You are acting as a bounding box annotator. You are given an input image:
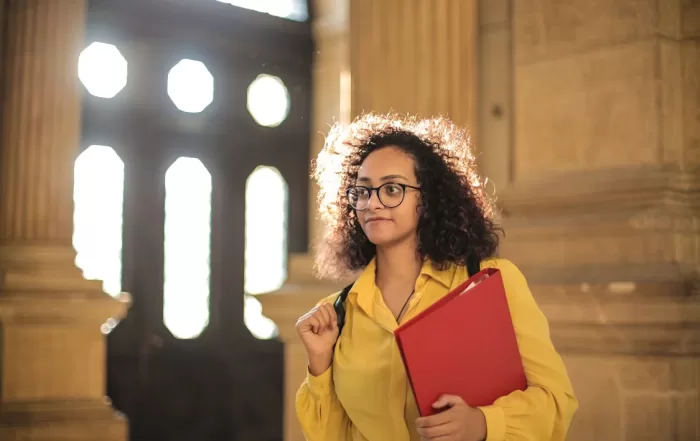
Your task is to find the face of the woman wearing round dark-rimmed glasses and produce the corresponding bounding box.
[355,146,420,247]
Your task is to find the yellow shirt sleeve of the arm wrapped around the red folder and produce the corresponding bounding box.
[480,259,578,441]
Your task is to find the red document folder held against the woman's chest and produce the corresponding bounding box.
[394,268,527,415]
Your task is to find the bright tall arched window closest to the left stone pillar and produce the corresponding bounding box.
[73,145,124,296]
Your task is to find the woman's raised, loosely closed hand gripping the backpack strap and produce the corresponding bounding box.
[296,303,339,376]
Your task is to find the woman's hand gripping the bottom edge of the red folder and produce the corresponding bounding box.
[416,395,486,441]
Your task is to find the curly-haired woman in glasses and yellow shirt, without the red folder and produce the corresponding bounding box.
[296,114,578,441]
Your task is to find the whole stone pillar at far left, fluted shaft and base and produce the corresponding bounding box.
[0,0,127,441]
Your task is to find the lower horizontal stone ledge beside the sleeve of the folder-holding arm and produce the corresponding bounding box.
[532,281,700,356]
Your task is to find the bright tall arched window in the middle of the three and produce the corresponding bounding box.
[163,157,212,339]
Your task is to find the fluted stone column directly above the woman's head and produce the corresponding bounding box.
[350,0,478,130]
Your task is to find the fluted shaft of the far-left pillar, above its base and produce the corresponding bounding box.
[0,0,80,245]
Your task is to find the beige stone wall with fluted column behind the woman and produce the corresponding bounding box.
[263,0,700,441]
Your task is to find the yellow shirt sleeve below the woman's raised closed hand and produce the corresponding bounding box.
[295,294,352,441]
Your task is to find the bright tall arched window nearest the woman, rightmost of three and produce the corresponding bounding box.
[244,166,288,338]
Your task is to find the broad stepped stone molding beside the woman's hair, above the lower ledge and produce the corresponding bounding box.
[499,167,700,289]
